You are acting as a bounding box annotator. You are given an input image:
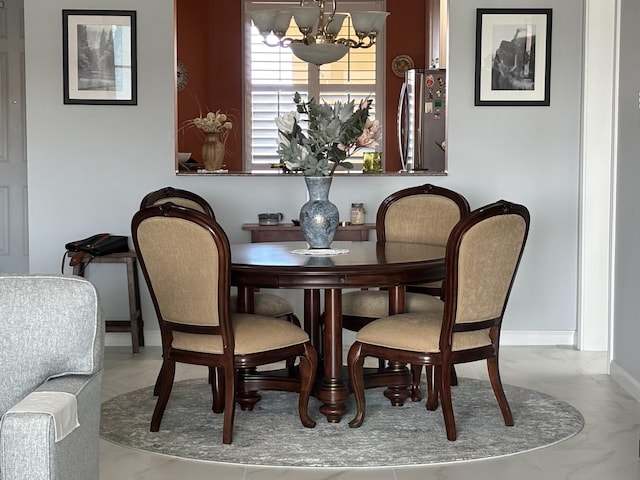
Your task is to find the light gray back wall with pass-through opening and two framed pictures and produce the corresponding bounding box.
[25,0,584,343]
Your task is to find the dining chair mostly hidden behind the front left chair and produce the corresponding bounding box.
[140,187,301,326]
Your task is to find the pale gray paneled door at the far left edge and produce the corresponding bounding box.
[0,0,29,273]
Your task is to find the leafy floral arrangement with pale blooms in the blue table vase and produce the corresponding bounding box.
[276,92,382,176]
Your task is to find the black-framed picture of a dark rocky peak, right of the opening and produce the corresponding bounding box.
[475,8,552,106]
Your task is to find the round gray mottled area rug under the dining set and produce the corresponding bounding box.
[101,378,584,468]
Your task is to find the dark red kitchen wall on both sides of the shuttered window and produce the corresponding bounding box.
[176,0,427,172]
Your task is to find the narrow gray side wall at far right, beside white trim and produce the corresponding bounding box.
[613,0,640,382]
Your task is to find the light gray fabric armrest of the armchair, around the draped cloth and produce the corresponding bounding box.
[0,370,102,480]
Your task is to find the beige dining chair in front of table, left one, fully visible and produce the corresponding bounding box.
[131,202,317,444]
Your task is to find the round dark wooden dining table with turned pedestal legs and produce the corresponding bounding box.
[231,242,445,422]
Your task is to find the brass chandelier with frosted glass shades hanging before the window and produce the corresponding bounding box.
[249,0,389,67]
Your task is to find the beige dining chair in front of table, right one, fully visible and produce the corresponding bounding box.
[347,200,529,440]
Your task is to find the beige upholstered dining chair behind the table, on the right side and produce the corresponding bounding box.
[342,184,470,394]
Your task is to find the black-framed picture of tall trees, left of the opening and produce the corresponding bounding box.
[62,10,138,105]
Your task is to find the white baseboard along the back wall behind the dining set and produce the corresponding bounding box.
[105,330,576,347]
